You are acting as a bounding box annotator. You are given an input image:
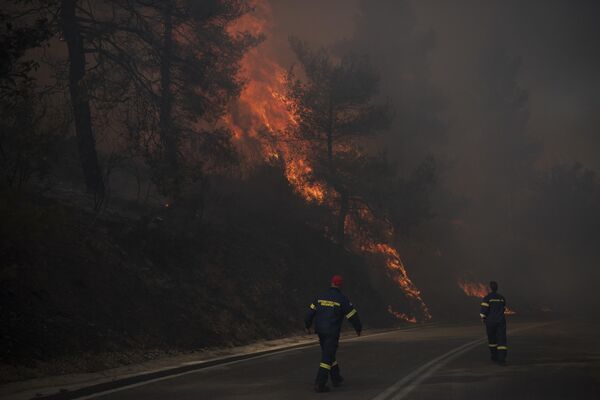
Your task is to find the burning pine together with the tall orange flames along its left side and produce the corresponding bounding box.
[220,1,431,322]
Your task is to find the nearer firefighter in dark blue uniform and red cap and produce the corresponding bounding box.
[304,275,362,393]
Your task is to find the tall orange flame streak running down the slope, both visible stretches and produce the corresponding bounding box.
[225,0,431,322]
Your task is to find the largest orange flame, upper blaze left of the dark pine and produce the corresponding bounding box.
[225,1,326,204]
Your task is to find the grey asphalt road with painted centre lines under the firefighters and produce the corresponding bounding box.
[72,320,600,400]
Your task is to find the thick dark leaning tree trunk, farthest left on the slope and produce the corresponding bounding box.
[60,0,104,198]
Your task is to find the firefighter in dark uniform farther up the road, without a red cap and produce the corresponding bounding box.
[479,281,508,364]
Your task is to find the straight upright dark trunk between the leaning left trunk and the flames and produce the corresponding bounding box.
[159,1,178,183]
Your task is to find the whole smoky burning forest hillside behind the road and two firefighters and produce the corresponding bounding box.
[0,0,600,381]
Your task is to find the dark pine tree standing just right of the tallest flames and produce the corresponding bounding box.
[287,38,390,245]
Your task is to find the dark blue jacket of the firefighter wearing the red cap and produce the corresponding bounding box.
[304,287,362,336]
